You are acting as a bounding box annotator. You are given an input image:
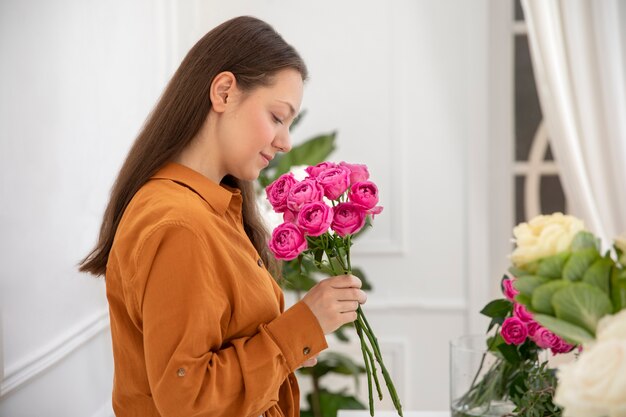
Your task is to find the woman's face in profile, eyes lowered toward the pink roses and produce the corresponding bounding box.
[217,69,303,180]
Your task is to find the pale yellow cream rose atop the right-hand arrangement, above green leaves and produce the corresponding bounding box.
[511,213,585,267]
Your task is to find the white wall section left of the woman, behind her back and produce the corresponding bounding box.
[0,0,172,417]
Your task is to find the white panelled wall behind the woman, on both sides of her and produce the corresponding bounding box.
[0,0,508,416]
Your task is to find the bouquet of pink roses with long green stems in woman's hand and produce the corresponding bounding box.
[265,162,402,416]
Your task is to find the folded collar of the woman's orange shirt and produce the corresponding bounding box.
[151,162,241,215]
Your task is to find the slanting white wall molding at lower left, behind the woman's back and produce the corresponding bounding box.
[0,309,109,399]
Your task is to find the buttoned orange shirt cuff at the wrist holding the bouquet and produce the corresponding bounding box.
[266,301,328,372]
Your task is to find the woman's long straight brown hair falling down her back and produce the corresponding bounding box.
[79,16,307,276]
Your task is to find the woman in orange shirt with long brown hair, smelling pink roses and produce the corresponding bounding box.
[80,17,366,417]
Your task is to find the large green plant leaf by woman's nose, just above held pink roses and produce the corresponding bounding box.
[274,132,337,178]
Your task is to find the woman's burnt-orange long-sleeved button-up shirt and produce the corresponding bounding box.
[106,163,327,417]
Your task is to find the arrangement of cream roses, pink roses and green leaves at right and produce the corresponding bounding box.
[460,213,626,417]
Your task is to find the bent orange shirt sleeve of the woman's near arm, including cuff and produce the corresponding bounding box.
[135,223,327,417]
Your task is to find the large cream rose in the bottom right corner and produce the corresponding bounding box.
[554,339,626,417]
